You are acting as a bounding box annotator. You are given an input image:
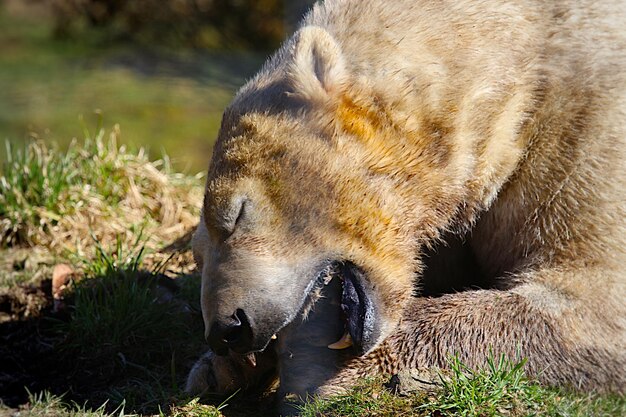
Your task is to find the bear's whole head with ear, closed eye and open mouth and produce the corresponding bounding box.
[193,27,447,355]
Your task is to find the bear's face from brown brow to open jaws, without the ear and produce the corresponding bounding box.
[193,108,413,354]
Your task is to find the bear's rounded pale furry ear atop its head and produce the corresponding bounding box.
[289,26,347,99]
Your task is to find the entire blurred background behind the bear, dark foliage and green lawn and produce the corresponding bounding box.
[0,0,313,173]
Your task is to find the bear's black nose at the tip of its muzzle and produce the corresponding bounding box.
[208,308,252,355]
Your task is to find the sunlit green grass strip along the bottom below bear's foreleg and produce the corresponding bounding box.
[301,355,626,417]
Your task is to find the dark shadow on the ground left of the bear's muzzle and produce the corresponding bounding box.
[0,271,195,412]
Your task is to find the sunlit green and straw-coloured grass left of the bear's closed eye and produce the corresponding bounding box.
[0,126,202,252]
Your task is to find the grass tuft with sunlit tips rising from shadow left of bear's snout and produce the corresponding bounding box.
[60,234,158,354]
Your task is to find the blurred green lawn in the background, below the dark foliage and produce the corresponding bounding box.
[0,5,264,171]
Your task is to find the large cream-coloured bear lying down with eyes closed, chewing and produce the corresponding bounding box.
[187,0,626,399]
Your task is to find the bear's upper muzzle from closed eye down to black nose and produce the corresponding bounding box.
[193,179,328,353]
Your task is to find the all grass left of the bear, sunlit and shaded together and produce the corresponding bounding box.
[0,126,206,415]
